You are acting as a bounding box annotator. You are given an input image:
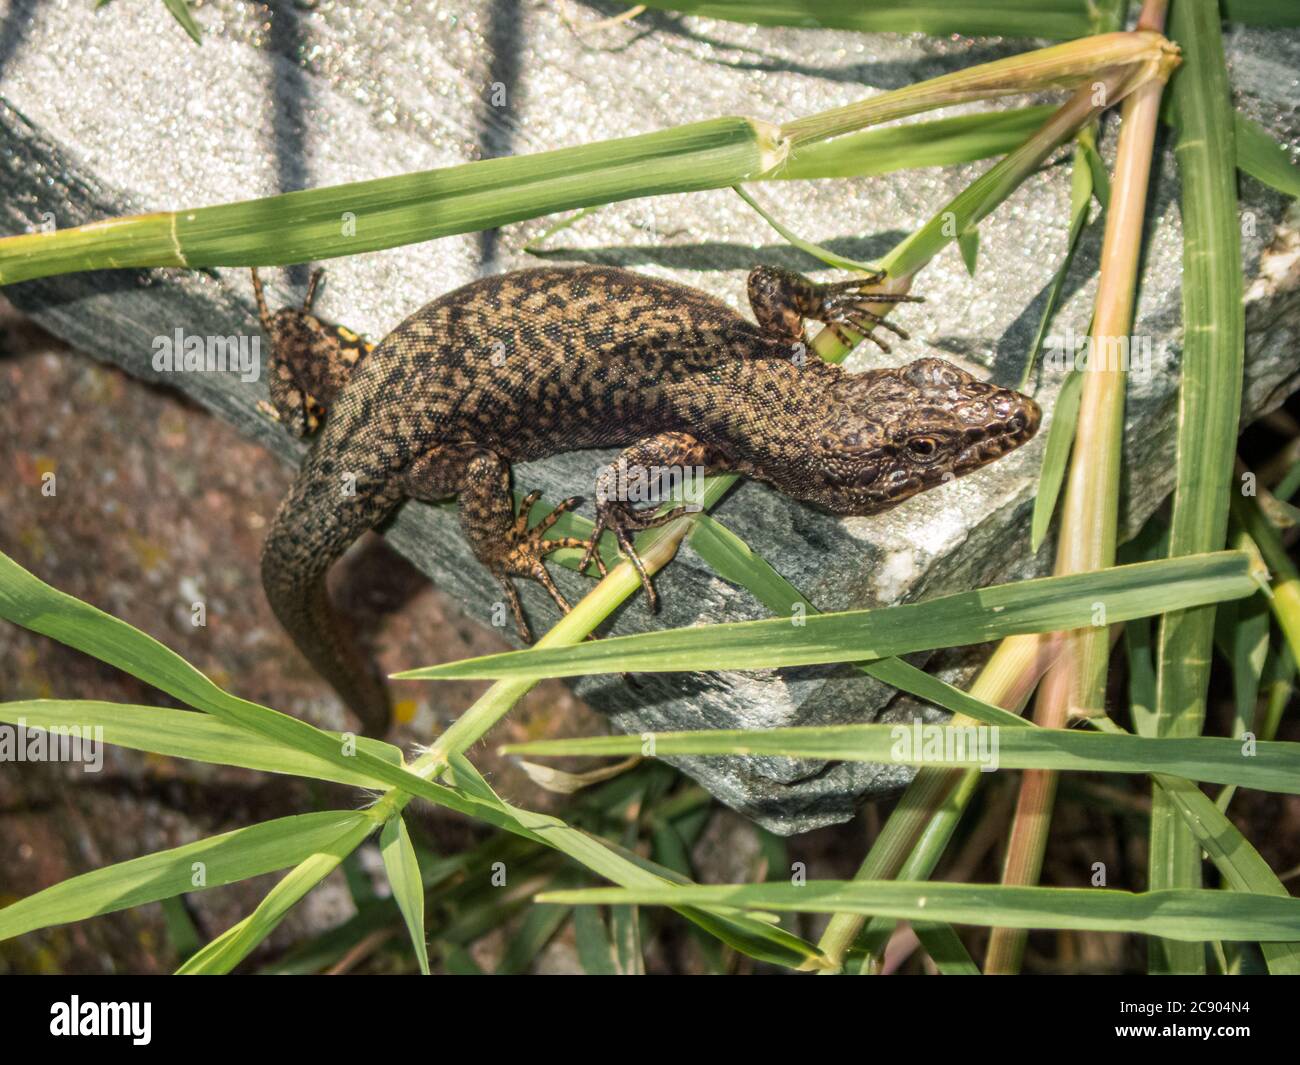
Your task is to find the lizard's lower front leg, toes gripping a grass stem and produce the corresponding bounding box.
[579,433,731,612]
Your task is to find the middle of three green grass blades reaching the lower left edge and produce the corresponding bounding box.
[0,700,402,788]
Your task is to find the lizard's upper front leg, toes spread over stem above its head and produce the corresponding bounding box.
[749,267,924,351]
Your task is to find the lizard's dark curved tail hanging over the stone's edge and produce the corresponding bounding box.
[261,460,400,736]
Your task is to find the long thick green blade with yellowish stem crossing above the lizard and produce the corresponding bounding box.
[0,33,1167,285]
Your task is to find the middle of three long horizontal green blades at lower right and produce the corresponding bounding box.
[503,722,1300,795]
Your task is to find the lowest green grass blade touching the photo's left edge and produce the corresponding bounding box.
[0,810,373,939]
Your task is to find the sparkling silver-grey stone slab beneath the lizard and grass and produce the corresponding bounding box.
[0,0,1300,832]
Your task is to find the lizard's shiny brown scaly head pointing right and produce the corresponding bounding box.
[805,359,1041,515]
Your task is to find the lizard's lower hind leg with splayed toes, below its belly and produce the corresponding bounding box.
[404,443,589,644]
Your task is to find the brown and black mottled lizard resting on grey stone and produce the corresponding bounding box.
[254,265,1040,735]
